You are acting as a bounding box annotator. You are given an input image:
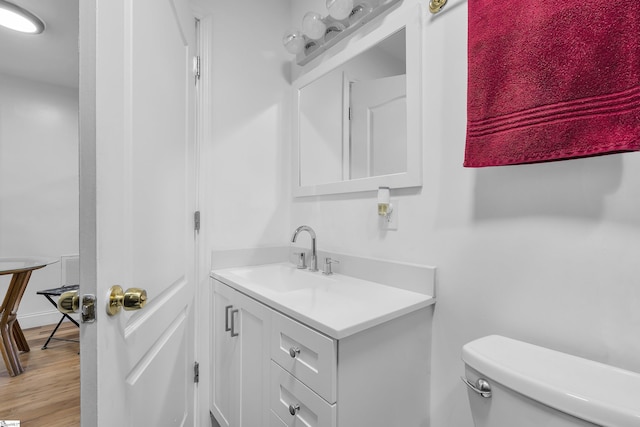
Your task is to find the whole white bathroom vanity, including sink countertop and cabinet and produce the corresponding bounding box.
[210,264,434,427]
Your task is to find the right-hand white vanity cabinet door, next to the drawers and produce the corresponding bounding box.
[234,292,271,427]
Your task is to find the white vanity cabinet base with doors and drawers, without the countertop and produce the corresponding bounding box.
[212,279,432,427]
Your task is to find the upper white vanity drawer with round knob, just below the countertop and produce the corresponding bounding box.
[271,313,337,403]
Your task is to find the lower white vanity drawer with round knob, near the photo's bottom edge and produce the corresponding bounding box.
[269,361,336,427]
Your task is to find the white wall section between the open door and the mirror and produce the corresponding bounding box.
[204,0,291,250]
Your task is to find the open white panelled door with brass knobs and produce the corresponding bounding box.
[79,0,196,427]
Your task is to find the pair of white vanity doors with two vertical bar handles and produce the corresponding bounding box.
[211,280,272,427]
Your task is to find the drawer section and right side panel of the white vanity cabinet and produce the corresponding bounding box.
[269,307,432,427]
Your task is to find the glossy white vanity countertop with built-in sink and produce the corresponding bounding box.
[211,263,435,339]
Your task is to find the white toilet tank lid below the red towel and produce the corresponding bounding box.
[462,335,640,427]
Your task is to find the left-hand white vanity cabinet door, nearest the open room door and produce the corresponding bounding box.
[211,280,240,427]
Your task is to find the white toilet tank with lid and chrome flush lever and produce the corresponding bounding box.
[462,335,640,427]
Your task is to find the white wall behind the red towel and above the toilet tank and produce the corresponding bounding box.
[289,0,640,427]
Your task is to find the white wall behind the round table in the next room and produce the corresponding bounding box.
[0,74,78,328]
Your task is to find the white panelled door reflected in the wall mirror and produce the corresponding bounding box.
[349,74,407,179]
